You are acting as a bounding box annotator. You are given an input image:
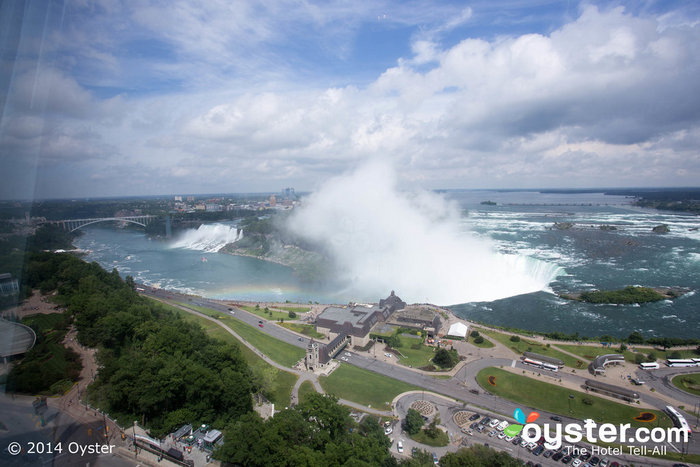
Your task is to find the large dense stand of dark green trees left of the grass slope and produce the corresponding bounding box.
[15,253,253,436]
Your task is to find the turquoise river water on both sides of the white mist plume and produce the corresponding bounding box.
[75,191,700,337]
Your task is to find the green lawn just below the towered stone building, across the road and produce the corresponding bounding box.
[319,364,421,410]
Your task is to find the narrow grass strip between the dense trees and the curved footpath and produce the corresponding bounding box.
[156,303,297,407]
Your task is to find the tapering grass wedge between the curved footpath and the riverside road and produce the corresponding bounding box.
[174,305,305,367]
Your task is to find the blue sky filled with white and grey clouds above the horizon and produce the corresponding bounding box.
[0,0,700,199]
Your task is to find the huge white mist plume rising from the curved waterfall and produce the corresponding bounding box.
[289,161,561,305]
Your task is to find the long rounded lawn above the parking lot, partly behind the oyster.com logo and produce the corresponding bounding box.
[476,368,673,428]
